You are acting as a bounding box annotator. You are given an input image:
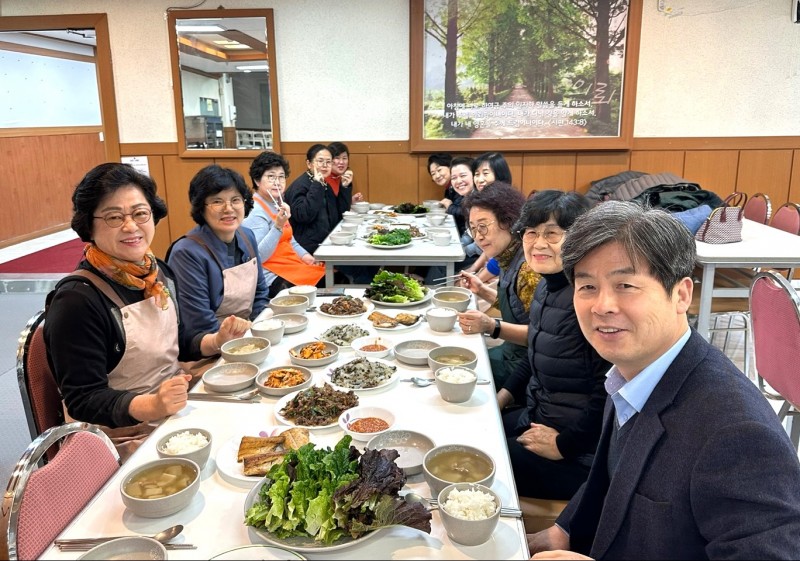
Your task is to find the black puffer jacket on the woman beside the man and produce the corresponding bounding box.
[503,273,611,459]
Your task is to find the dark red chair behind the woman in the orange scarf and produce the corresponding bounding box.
[17,310,64,458]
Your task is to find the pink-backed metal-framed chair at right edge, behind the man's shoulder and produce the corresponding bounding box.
[750,270,800,448]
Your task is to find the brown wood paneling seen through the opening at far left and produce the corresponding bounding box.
[0,127,105,247]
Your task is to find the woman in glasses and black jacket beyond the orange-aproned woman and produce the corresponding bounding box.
[286,144,340,253]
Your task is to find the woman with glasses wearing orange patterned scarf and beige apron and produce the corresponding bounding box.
[44,163,236,459]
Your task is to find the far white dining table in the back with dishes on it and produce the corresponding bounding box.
[314,210,466,287]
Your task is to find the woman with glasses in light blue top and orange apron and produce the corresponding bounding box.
[242,152,325,298]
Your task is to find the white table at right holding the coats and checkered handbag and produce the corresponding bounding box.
[695,218,800,339]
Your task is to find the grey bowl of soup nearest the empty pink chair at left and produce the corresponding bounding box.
[120,458,200,518]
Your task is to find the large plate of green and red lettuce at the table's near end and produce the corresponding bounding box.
[244,435,431,552]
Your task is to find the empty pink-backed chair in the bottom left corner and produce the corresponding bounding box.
[0,422,120,560]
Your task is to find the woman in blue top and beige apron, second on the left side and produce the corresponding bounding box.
[167,164,269,358]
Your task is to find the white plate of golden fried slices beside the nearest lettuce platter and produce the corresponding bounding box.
[216,426,311,487]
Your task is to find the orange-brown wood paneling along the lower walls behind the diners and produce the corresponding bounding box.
[7,135,788,257]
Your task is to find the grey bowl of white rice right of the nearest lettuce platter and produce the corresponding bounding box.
[438,483,501,545]
